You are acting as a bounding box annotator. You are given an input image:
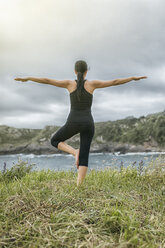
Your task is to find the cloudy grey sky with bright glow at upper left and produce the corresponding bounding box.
[0,0,165,129]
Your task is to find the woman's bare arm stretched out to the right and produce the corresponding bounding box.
[91,76,147,89]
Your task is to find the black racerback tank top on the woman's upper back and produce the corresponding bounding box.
[70,79,93,111]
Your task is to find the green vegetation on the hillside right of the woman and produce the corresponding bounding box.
[95,111,165,147]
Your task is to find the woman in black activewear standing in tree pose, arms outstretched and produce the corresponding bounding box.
[15,60,147,186]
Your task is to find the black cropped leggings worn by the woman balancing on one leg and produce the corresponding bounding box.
[51,116,95,167]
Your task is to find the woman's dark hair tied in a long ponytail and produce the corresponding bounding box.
[75,60,88,101]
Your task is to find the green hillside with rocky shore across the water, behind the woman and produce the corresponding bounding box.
[0,111,165,154]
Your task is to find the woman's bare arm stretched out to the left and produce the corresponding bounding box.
[15,77,70,88]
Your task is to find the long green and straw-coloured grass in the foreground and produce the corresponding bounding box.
[0,160,165,248]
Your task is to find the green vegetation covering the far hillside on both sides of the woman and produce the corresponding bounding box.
[0,111,165,154]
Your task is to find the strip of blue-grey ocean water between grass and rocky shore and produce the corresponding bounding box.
[0,152,165,171]
